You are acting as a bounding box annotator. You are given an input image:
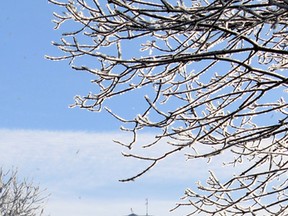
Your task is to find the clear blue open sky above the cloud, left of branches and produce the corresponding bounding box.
[0,0,119,131]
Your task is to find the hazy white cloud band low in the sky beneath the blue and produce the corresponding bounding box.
[0,129,243,216]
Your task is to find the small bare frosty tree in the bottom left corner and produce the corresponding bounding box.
[0,169,47,216]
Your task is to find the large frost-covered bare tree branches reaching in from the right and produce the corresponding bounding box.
[47,0,288,215]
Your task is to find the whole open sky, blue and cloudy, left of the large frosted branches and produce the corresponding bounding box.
[0,0,210,216]
